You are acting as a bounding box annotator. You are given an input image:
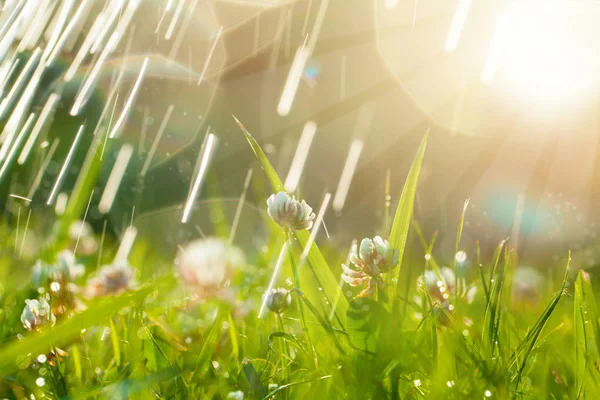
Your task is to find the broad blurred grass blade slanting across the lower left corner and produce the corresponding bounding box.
[0,286,156,376]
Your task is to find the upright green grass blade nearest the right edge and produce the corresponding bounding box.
[573,273,588,399]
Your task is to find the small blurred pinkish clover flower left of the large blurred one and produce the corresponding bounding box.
[86,261,135,297]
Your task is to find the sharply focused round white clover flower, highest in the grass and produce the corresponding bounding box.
[267,192,315,231]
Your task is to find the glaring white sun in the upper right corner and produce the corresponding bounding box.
[482,0,600,102]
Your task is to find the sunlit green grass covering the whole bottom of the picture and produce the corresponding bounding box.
[0,124,600,399]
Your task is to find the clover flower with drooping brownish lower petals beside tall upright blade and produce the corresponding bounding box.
[342,236,398,297]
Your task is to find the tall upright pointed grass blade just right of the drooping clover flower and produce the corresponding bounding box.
[389,130,429,301]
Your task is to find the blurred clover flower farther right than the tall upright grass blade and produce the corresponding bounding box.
[417,267,477,312]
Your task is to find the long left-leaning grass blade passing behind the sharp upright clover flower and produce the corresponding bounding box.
[234,117,348,323]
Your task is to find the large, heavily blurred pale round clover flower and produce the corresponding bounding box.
[176,238,245,296]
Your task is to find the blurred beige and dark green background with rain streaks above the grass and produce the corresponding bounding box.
[0,0,600,267]
